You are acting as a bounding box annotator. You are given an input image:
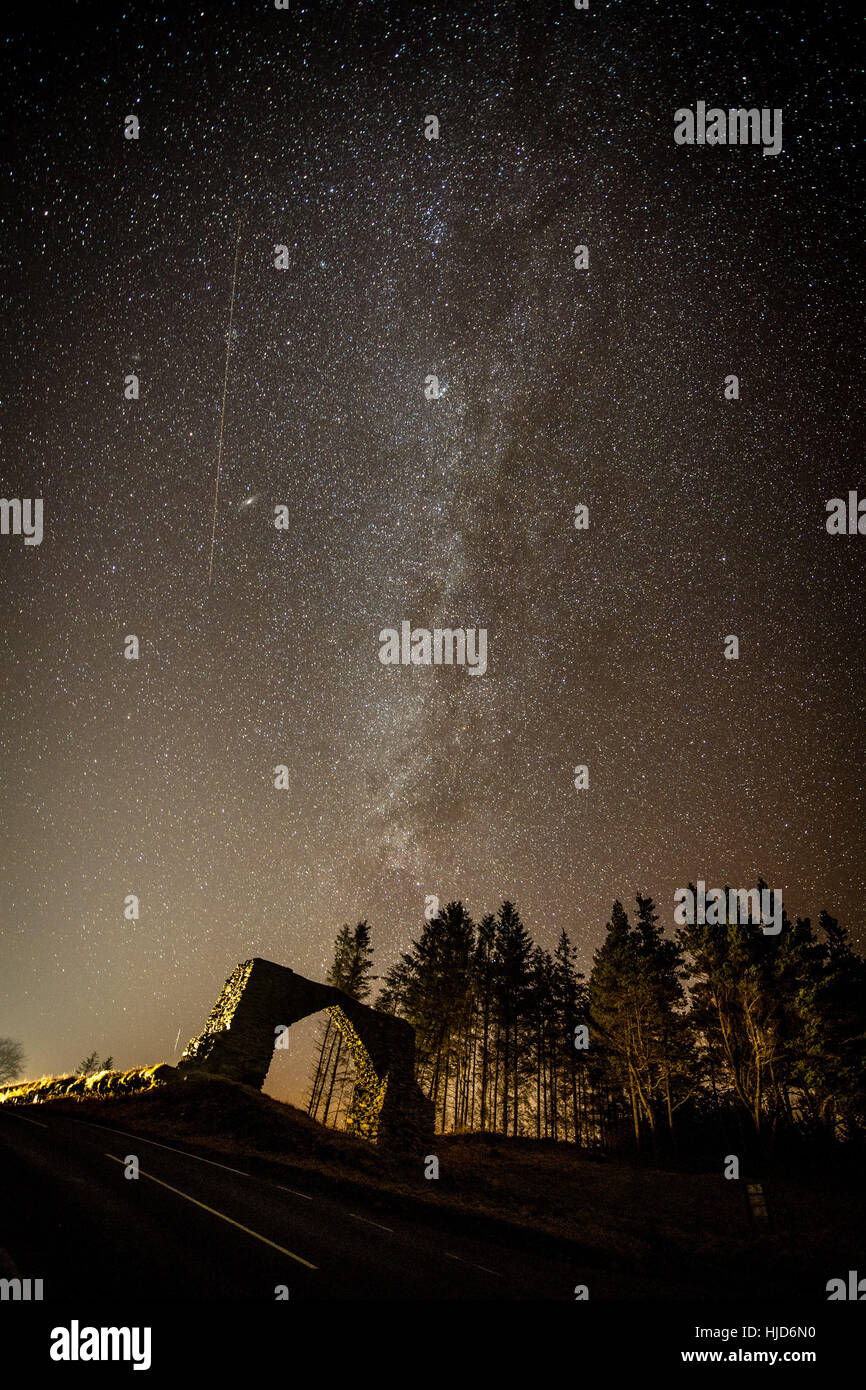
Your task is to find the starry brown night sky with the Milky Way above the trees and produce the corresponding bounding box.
[0,0,866,1097]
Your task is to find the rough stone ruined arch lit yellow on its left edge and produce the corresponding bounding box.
[178,958,434,1148]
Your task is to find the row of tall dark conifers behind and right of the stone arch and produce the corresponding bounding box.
[310,884,866,1154]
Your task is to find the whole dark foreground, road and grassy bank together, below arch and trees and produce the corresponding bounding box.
[0,1081,866,1301]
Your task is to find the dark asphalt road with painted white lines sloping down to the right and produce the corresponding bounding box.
[0,1106,633,1301]
